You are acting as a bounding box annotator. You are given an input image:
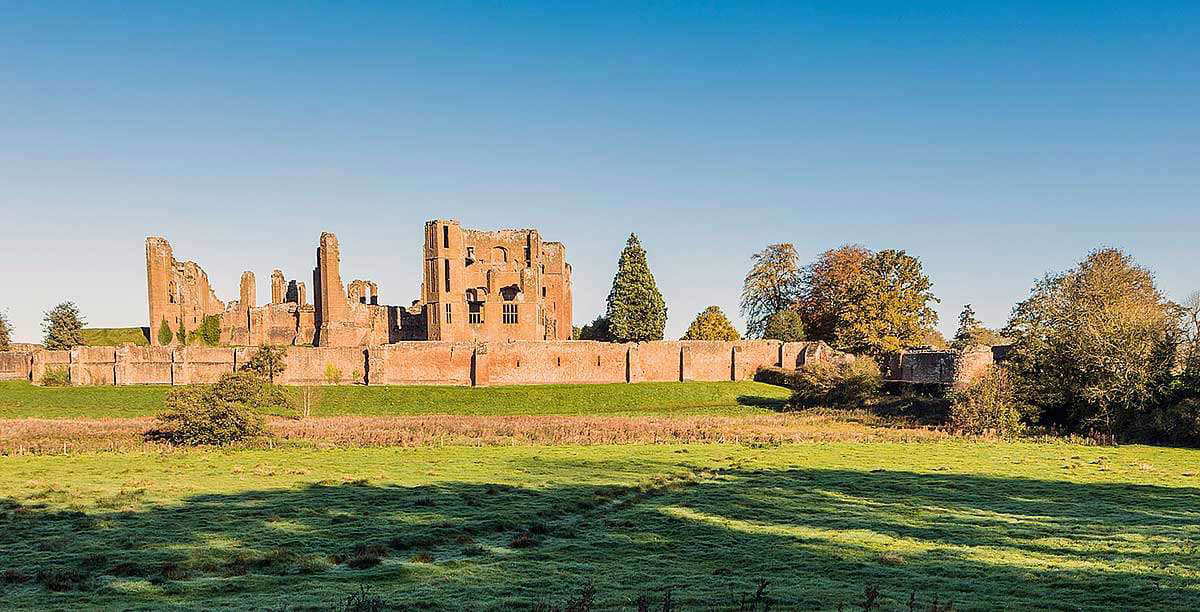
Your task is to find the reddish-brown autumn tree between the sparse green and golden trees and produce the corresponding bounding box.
[797,245,871,344]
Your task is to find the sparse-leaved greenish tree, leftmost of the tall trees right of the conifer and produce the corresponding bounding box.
[742,242,802,338]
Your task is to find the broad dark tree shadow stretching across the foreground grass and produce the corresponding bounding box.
[0,460,1200,610]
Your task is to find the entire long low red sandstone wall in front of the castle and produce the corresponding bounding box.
[23,341,823,385]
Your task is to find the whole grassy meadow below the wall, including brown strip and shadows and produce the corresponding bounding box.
[0,383,1200,610]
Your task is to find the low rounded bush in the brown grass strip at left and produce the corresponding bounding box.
[151,374,266,446]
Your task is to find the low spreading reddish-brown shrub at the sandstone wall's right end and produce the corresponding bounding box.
[791,356,883,408]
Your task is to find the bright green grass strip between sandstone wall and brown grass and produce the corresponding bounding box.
[0,380,787,419]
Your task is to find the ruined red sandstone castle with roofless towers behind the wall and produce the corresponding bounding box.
[145,220,571,347]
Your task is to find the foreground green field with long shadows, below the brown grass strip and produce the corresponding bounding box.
[0,442,1200,610]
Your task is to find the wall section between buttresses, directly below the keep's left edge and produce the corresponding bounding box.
[367,342,474,386]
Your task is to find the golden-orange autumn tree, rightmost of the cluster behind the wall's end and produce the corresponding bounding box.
[838,250,937,355]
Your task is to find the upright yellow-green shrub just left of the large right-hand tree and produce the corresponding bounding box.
[950,365,1025,437]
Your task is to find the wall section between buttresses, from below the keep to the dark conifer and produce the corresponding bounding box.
[487,341,629,385]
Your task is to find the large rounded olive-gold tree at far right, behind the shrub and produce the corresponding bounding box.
[1004,248,1180,436]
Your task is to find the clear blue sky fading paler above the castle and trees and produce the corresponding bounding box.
[0,0,1200,341]
